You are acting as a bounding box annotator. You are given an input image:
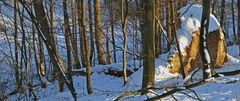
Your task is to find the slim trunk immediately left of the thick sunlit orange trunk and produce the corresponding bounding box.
[88,0,94,64]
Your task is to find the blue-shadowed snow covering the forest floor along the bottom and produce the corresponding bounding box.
[0,46,240,101]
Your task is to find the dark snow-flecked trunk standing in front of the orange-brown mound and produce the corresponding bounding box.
[200,0,213,79]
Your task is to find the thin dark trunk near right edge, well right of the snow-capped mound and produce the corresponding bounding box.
[231,0,237,44]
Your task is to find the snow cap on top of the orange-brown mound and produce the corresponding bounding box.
[177,5,220,54]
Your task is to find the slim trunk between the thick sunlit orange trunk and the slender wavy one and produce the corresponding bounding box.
[109,0,117,63]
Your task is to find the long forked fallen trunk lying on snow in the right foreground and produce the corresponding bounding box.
[114,69,240,101]
